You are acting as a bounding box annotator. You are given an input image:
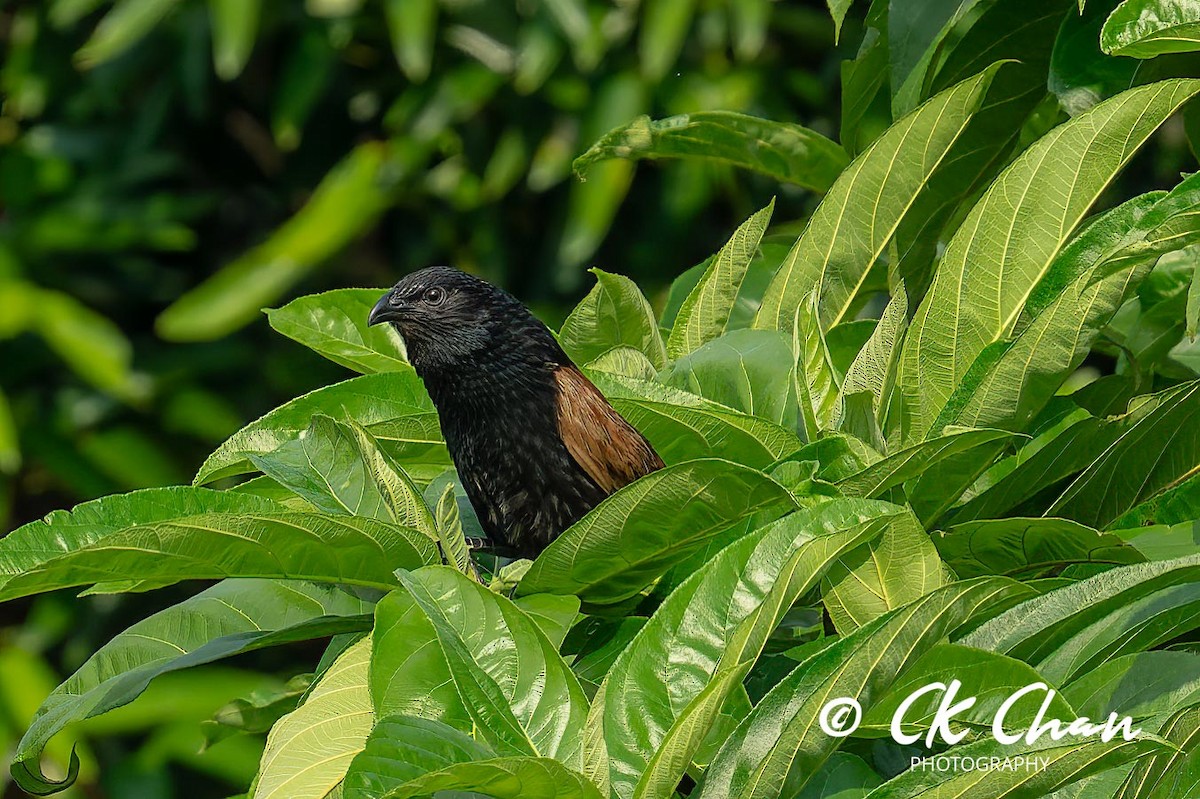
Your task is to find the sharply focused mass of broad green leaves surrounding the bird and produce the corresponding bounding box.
[7,0,1200,799]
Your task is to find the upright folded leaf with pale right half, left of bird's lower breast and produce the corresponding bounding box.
[250,414,436,539]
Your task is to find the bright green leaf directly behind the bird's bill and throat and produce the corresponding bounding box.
[266,289,408,374]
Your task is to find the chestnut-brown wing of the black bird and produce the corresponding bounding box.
[554,366,662,494]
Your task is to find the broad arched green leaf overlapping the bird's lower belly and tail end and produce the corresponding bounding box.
[517,459,796,605]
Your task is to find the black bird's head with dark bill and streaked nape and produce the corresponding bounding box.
[367,266,565,379]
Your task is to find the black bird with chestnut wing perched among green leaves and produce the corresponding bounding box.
[367,266,664,558]
